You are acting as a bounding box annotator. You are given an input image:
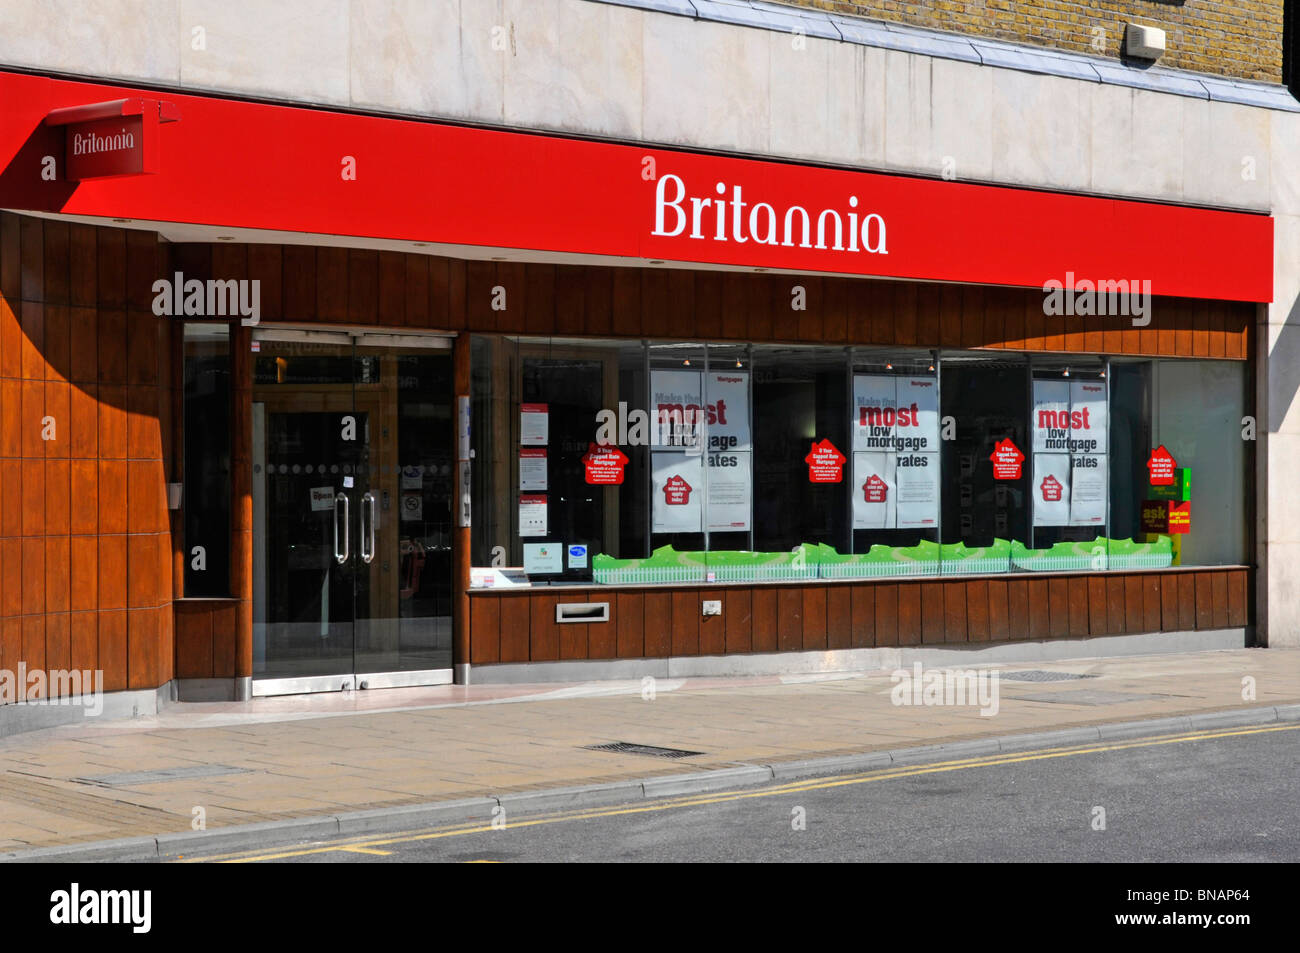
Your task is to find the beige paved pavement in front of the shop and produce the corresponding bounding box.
[0,649,1300,859]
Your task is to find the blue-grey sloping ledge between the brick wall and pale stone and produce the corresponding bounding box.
[592,0,1300,112]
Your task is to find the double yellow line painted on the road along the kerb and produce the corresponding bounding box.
[185,724,1300,863]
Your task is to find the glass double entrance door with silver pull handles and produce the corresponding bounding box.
[254,332,452,694]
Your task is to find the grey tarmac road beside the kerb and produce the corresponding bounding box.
[213,725,1300,863]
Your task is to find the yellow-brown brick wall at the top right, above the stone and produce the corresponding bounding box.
[783,0,1283,83]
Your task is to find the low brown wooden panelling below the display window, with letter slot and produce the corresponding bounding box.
[469,567,1252,664]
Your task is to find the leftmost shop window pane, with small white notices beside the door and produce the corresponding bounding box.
[471,338,649,582]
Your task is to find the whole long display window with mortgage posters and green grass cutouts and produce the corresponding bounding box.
[473,337,1248,585]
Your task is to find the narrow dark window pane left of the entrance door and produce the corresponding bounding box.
[181,324,230,598]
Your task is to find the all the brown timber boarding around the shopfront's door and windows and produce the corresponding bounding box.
[0,213,1256,690]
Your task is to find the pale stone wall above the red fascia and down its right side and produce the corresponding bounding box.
[0,0,1300,646]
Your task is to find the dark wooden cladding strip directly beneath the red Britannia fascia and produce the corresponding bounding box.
[195,243,1256,360]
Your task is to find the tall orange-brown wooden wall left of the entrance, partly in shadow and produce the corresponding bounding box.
[0,213,176,690]
